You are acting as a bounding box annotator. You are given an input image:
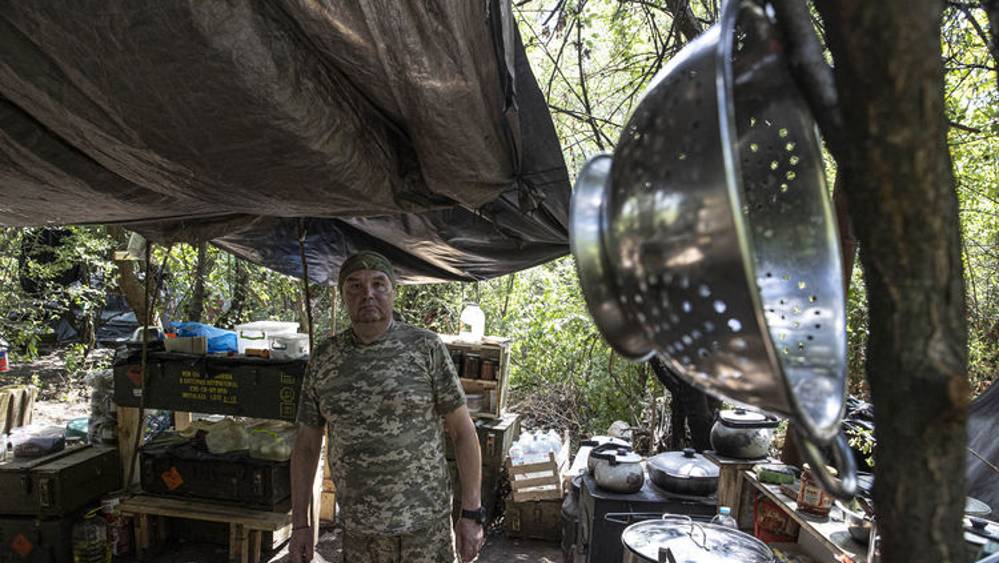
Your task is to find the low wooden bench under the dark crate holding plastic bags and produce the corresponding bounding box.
[121,495,292,563]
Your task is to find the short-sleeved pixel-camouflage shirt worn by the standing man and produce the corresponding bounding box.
[298,322,465,535]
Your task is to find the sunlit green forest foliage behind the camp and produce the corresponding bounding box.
[0,0,999,448]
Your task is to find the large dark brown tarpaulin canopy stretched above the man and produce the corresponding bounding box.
[0,0,569,282]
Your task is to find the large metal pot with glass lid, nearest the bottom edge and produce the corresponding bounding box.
[621,514,774,563]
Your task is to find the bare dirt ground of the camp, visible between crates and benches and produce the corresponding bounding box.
[7,349,562,563]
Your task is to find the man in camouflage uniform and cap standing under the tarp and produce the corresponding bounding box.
[290,252,483,563]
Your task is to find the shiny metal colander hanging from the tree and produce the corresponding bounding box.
[571,0,855,497]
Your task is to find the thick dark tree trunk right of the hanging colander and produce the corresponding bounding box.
[816,0,968,563]
